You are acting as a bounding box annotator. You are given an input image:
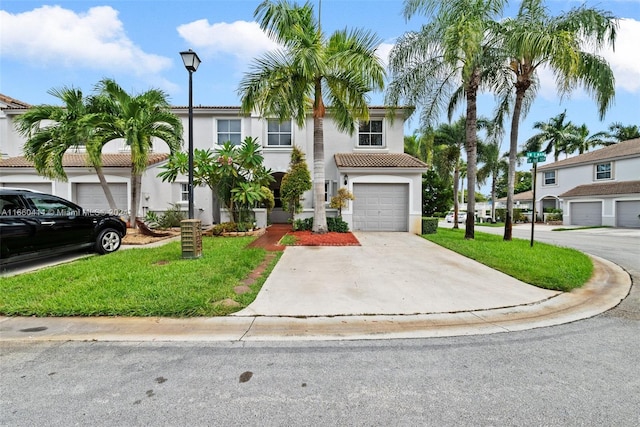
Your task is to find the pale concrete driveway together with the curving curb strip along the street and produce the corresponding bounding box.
[0,232,631,341]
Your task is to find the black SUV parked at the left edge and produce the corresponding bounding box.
[0,188,127,265]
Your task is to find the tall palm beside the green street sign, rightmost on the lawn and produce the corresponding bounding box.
[496,0,618,240]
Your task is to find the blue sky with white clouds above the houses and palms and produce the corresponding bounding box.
[0,0,640,149]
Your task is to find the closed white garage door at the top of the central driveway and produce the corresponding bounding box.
[353,184,409,231]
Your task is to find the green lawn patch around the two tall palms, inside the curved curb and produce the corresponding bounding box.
[422,228,593,291]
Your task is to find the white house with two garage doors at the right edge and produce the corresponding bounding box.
[536,138,640,228]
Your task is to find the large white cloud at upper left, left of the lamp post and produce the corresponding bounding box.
[0,6,171,75]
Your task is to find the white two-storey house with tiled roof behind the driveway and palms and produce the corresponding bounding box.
[0,97,427,233]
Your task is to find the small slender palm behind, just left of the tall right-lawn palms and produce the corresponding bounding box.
[433,117,466,228]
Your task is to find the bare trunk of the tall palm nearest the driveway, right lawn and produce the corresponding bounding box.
[464,72,480,239]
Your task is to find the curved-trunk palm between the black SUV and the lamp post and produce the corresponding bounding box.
[92,79,182,228]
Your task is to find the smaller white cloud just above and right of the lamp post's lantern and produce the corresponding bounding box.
[178,19,278,63]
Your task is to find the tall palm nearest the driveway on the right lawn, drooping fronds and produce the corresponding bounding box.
[386,0,506,239]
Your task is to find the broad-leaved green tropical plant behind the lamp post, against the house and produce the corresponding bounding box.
[158,136,273,222]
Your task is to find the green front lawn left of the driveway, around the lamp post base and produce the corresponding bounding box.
[0,237,278,317]
